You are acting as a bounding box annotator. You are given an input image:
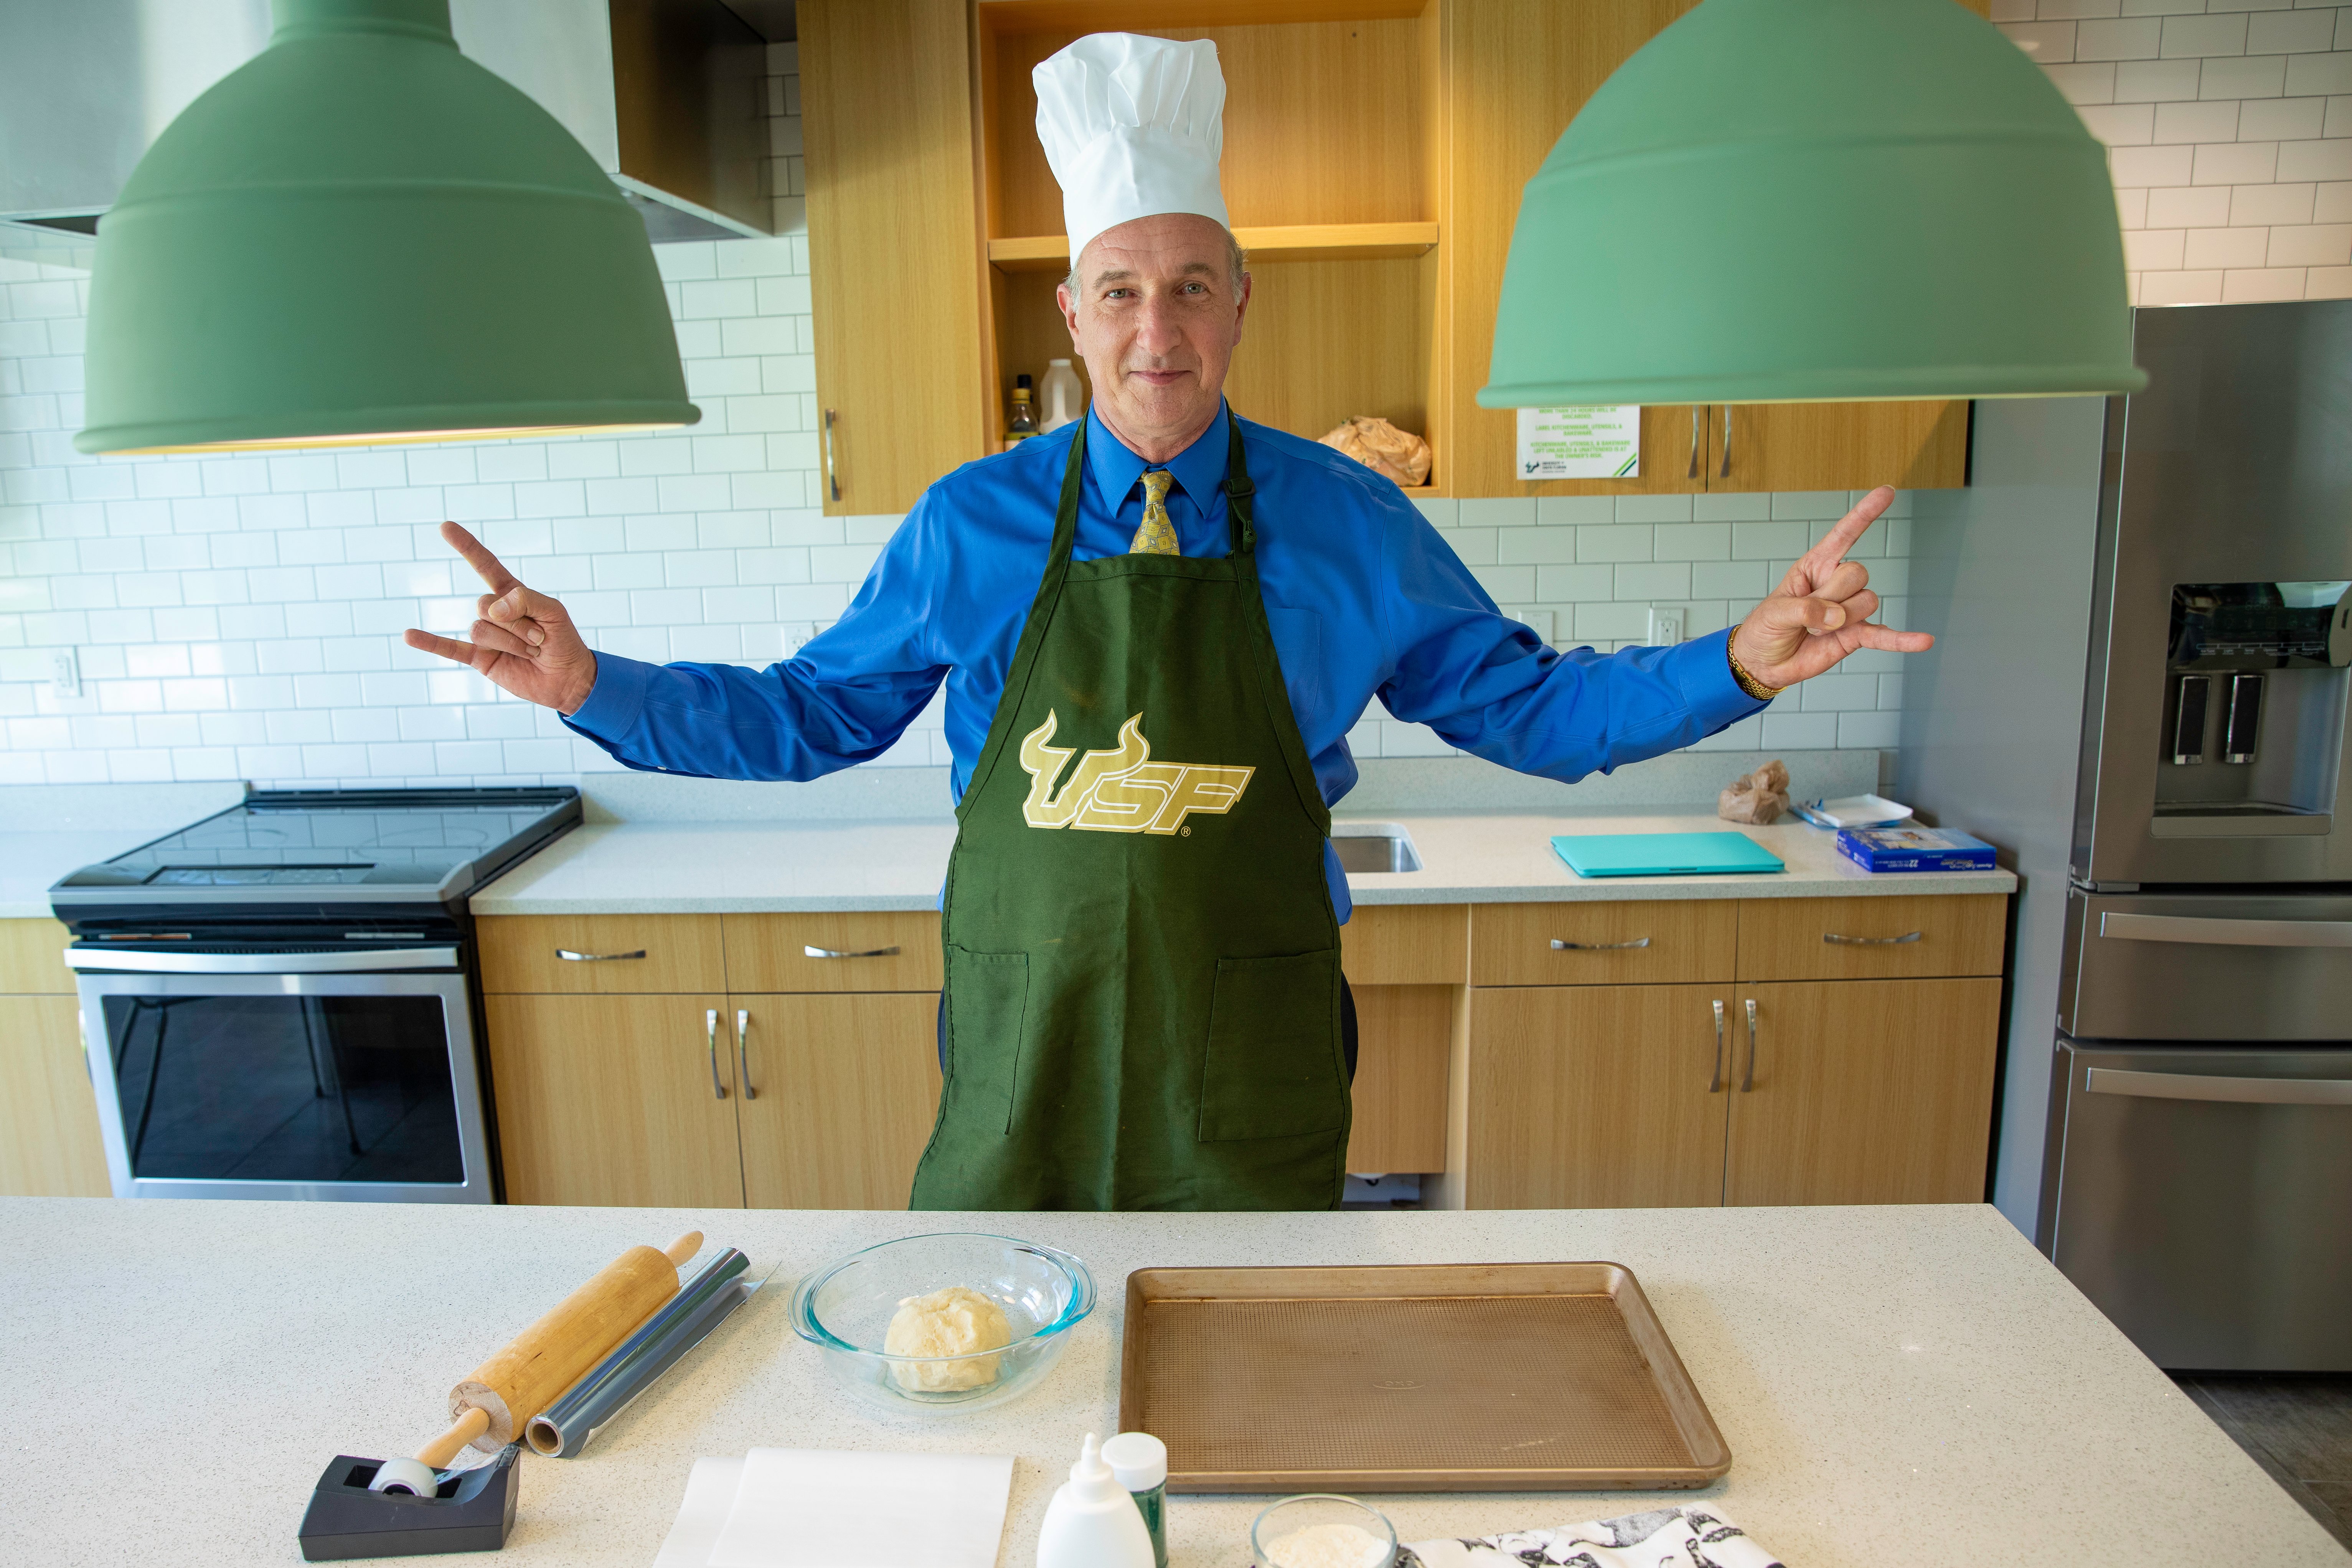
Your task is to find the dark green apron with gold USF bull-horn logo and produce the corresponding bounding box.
[912,414,1350,1209]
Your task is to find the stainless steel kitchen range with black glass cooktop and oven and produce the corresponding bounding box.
[49,790,581,1204]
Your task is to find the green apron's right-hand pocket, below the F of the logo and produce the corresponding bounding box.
[1199,947,1348,1143]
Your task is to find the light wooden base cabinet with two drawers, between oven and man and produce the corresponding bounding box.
[477,910,938,1209]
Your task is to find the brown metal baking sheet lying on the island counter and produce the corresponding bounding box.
[1120,1262,1731,1493]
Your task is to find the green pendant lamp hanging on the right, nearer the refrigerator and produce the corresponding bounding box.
[1477,0,2147,409]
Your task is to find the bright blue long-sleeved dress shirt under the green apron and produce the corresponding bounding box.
[569,411,1762,919]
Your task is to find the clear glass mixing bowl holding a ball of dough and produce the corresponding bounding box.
[793,1232,1094,1413]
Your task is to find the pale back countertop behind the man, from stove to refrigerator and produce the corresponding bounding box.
[473,809,2018,915]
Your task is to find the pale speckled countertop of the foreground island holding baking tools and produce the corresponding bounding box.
[0,1199,2342,1568]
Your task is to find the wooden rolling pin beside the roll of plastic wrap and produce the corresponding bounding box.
[442,1230,703,1462]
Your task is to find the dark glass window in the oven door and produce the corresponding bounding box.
[106,994,466,1182]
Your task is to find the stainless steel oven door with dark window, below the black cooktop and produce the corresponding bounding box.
[66,945,494,1204]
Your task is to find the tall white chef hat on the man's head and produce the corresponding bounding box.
[1030,33,1228,261]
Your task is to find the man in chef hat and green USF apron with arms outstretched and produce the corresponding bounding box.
[409,33,1929,1209]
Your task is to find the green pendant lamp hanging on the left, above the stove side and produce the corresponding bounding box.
[73,0,701,451]
